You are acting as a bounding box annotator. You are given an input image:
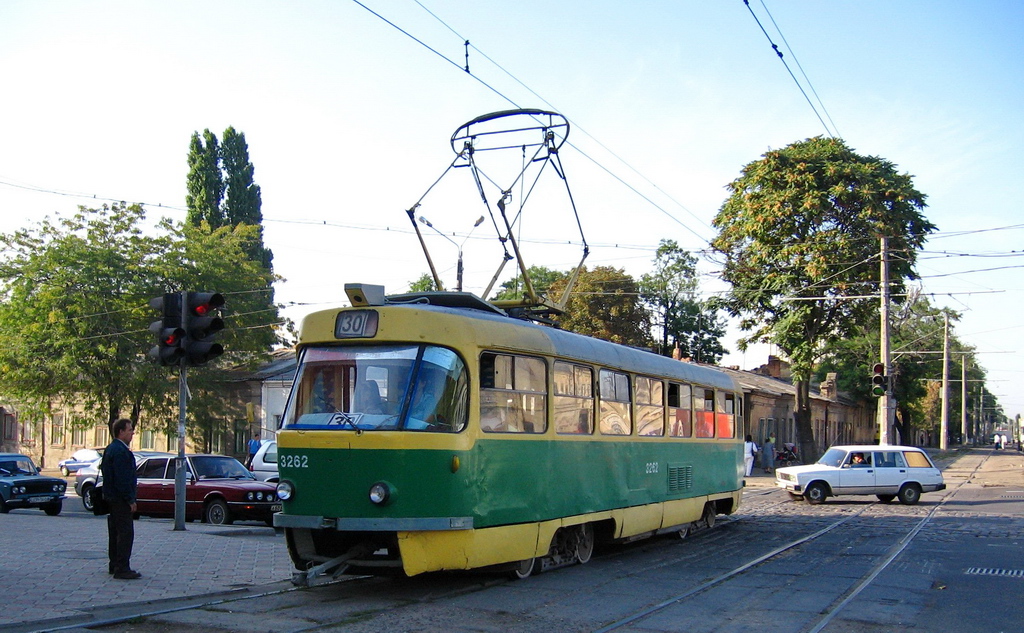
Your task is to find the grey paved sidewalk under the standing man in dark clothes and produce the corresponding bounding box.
[0,510,292,630]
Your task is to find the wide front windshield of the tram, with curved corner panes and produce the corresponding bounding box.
[282,345,469,432]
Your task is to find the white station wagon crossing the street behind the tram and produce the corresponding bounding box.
[775,445,946,506]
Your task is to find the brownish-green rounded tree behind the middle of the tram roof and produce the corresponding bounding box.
[549,266,650,347]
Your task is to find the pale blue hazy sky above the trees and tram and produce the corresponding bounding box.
[0,0,1024,424]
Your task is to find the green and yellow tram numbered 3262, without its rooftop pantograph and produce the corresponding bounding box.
[274,287,742,580]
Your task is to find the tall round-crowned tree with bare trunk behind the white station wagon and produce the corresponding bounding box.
[712,137,935,457]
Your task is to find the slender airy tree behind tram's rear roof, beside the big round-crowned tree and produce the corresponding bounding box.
[640,240,725,364]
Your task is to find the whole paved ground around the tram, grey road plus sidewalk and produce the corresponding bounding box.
[0,449,1024,633]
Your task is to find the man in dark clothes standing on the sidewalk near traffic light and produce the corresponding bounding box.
[99,418,142,580]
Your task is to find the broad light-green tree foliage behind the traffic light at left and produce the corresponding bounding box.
[0,204,279,432]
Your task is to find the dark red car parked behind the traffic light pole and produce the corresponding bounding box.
[135,455,281,526]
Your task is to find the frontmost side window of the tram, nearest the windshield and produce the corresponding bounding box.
[480,353,548,433]
